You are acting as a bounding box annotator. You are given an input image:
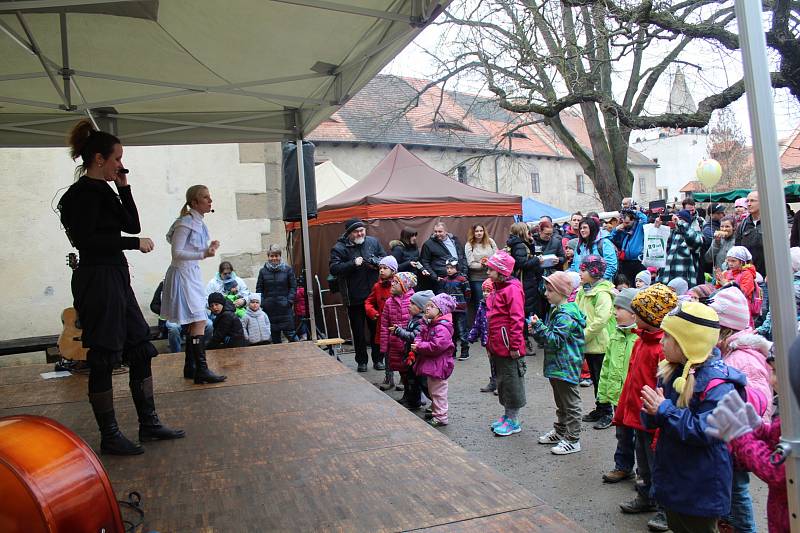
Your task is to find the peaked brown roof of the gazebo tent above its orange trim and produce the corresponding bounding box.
[319,144,522,214]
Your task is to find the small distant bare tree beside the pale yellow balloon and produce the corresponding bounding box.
[708,108,755,191]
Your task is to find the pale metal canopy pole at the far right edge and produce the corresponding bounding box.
[735,0,800,531]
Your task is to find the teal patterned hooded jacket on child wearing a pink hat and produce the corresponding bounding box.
[533,302,586,385]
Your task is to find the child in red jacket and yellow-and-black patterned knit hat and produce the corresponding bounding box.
[606,283,678,530]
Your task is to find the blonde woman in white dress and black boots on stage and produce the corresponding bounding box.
[161,185,226,383]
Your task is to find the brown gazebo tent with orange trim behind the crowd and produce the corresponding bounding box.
[287,145,522,333]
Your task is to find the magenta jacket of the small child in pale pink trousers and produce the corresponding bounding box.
[414,314,456,379]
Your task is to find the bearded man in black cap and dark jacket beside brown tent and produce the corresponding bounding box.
[329,218,386,372]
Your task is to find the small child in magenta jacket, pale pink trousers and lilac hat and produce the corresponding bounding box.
[411,294,456,427]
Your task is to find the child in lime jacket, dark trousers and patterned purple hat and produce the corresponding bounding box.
[575,255,614,422]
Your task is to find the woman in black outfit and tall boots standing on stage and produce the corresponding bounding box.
[58,120,184,455]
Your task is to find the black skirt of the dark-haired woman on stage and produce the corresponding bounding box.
[72,265,157,363]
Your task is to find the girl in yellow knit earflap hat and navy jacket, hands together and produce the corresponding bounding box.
[642,302,746,533]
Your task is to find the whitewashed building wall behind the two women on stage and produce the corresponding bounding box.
[0,144,270,339]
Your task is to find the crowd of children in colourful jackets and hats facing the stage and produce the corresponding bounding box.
[364,234,800,532]
